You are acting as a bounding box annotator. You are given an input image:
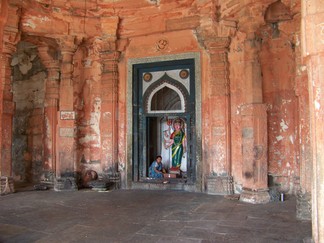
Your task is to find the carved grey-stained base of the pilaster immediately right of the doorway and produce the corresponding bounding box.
[206,176,234,195]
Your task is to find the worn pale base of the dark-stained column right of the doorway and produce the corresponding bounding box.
[240,188,270,204]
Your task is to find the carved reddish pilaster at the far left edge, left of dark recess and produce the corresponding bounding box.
[0,1,20,194]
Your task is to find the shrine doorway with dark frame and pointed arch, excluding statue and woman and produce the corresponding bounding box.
[126,53,202,191]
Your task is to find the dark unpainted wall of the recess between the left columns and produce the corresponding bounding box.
[11,42,46,182]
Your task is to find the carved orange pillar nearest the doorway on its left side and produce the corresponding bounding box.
[100,43,120,173]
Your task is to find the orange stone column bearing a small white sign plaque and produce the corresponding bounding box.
[54,36,77,191]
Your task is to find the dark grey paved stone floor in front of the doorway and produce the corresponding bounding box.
[0,190,311,243]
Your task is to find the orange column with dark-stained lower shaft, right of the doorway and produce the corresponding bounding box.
[240,31,270,204]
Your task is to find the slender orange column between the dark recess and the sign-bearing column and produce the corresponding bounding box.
[38,46,60,183]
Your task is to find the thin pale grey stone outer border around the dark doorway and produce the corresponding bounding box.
[126,52,202,192]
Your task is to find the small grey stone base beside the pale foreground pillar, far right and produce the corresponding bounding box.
[296,191,312,220]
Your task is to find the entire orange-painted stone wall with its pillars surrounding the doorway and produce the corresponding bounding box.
[0,0,323,241]
